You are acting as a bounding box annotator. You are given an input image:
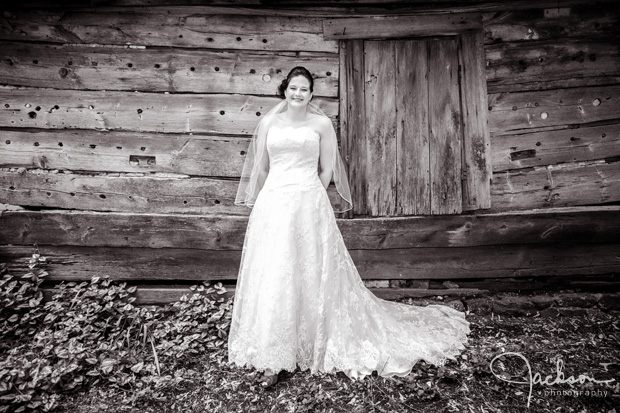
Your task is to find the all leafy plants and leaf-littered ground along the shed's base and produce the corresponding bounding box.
[0,254,620,413]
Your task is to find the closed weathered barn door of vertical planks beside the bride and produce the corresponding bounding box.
[341,36,488,216]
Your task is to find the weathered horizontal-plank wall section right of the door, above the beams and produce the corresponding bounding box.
[483,5,620,211]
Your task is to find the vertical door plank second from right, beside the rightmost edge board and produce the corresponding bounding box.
[428,39,463,214]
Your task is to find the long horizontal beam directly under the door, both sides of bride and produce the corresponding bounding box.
[0,206,620,250]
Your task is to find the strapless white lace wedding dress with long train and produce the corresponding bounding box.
[228,126,469,378]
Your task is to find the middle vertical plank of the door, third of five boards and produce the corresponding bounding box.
[396,40,431,215]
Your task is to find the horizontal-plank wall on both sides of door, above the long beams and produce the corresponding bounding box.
[0,5,620,214]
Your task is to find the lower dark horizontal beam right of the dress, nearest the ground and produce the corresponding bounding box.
[350,243,620,280]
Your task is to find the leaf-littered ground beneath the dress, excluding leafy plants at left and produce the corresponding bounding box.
[58,300,620,413]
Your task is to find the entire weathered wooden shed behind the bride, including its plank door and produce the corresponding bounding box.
[0,0,620,303]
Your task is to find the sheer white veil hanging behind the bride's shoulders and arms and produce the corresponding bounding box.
[235,100,352,212]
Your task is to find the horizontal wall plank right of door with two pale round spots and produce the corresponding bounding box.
[488,85,620,134]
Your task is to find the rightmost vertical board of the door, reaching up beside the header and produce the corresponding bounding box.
[459,30,492,210]
